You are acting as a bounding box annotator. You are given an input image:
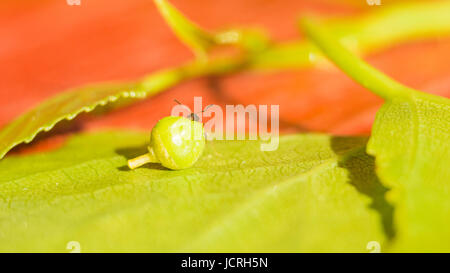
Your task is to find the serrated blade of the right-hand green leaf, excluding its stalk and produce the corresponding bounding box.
[367,95,450,252]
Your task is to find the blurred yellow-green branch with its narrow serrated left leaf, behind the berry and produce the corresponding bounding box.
[0,0,450,158]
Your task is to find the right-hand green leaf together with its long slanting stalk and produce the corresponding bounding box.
[303,19,450,251]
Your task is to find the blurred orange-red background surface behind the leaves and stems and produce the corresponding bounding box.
[0,0,450,152]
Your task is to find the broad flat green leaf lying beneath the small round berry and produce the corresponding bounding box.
[0,132,392,252]
